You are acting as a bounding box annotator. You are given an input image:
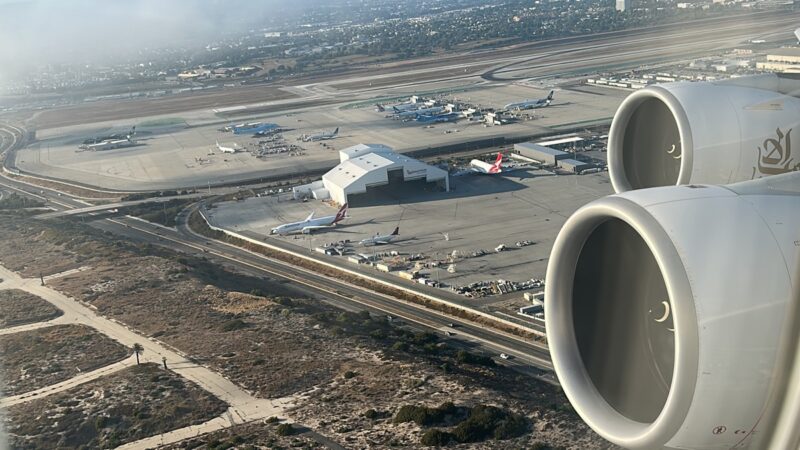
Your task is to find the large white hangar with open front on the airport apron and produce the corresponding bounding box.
[293,144,450,205]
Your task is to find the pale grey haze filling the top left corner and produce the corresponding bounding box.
[0,0,300,75]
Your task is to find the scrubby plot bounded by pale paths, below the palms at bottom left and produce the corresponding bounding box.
[6,364,227,449]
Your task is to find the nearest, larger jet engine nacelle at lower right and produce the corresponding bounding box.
[545,173,800,449]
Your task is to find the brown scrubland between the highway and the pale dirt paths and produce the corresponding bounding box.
[0,216,606,449]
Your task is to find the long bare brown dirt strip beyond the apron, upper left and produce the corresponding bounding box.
[33,86,296,129]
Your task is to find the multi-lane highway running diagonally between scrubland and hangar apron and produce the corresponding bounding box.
[0,133,557,384]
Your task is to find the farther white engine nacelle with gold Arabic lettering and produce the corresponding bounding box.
[608,74,800,192]
